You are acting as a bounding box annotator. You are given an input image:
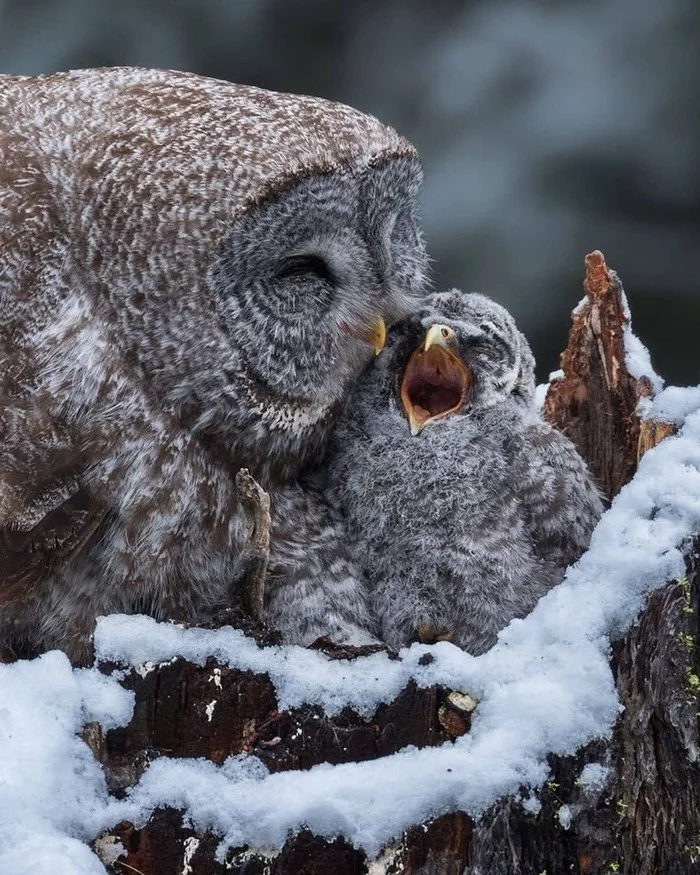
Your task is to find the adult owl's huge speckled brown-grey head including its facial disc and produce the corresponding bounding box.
[0,68,425,477]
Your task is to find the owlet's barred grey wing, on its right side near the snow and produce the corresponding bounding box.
[514,422,603,567]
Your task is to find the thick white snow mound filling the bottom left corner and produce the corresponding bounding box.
[0,651,132,875]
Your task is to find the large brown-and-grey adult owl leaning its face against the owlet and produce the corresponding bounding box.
[0,68,425,661]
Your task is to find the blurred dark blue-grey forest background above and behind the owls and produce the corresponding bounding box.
[0,0,700,383]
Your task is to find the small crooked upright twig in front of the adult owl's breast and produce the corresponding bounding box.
[236,468,270,622]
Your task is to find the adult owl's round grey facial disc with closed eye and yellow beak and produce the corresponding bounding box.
[211,157,426,417]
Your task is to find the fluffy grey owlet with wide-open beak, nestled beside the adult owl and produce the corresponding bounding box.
[325,290,602,654]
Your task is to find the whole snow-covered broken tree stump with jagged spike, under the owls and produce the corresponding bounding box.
[0,253,700,875]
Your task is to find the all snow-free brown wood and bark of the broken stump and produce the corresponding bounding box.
[94,252,700,875]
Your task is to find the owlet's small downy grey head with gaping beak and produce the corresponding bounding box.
[399,289,535,435]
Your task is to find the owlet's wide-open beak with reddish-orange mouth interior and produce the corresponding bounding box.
[401,325,472,436]
